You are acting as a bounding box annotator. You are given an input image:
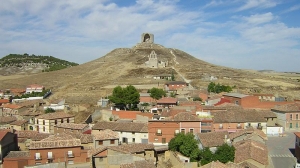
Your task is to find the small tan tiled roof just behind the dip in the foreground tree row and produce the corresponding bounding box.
[197,131,229,147]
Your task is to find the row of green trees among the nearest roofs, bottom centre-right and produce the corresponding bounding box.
[169,133,235,165]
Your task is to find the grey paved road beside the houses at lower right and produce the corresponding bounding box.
[266,132,296,168]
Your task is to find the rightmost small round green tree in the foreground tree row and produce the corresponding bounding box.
[215,144,235,163]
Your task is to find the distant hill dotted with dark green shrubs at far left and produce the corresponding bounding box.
[0,53,78,75]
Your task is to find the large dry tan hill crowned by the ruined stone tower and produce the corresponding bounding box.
[0,43,300,104]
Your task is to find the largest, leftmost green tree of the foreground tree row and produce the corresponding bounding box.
[168,133,200,161]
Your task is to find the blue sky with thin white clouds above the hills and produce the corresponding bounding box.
[0,0,300,72]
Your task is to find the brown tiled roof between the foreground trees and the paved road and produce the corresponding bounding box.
[233,140,269,165]
